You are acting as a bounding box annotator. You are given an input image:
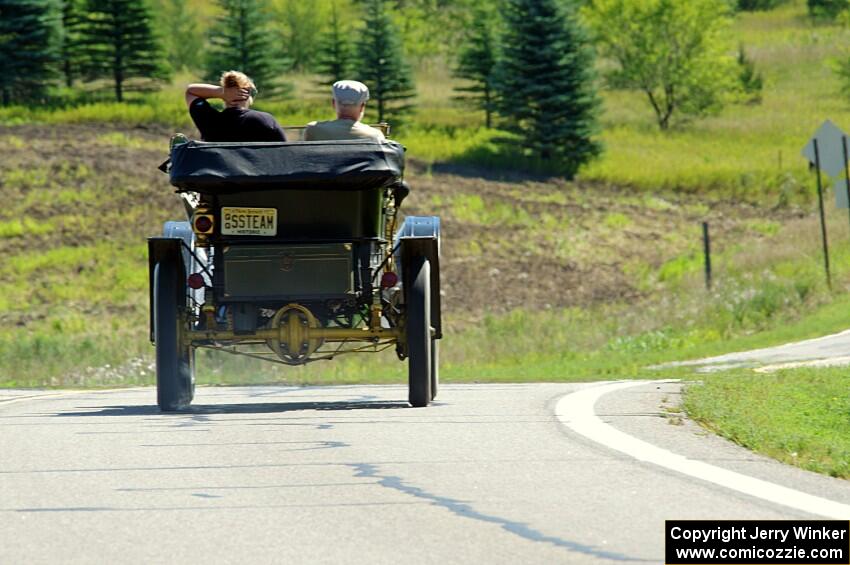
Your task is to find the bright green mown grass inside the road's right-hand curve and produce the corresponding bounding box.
[685,368,850,479]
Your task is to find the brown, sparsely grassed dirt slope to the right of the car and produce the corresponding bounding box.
[406,164,802,321]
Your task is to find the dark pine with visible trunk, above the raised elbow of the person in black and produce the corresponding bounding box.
[79,0,169,102]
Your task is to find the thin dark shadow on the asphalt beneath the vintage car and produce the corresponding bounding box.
[54,400,410,417]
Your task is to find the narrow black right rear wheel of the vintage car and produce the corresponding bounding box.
[406,256,434,407]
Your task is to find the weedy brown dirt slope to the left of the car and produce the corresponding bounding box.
[0,125,180,254]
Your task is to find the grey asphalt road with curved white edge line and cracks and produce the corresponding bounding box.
[0,382,850,564]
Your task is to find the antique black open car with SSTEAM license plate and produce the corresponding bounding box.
[148,135,442,411]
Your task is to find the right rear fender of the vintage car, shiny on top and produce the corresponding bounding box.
[395,216,443,339]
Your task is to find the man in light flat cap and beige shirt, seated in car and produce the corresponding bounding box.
[304,80,384,141]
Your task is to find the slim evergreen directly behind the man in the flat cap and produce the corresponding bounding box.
[357,0,416,122]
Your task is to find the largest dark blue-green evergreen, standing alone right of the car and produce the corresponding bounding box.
[496,0,601,177]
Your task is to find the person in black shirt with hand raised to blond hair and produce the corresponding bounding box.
[186,71,286,141]
